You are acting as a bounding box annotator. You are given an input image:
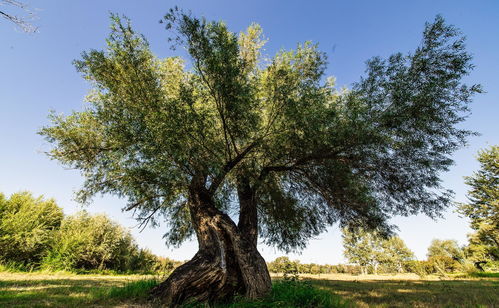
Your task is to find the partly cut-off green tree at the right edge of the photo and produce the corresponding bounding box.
[458,146,499,267]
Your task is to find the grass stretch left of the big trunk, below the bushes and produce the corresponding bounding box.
[0,273,158,308]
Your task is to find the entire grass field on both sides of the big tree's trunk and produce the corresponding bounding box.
[0,272,499,308]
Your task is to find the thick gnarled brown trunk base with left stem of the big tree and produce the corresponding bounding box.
[152,179,271,307]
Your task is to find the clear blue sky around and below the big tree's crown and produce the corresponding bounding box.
[0,0,499,263]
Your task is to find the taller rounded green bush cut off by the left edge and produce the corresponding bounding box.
[0,192,63,267]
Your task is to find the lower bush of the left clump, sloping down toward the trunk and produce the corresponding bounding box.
[42,211,157,272]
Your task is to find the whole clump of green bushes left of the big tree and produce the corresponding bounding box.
[0,192,180,272]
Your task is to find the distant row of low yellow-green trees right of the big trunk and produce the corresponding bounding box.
[267,236,499,277]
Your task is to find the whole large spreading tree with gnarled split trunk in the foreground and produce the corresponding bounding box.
[41,10,480,306]
